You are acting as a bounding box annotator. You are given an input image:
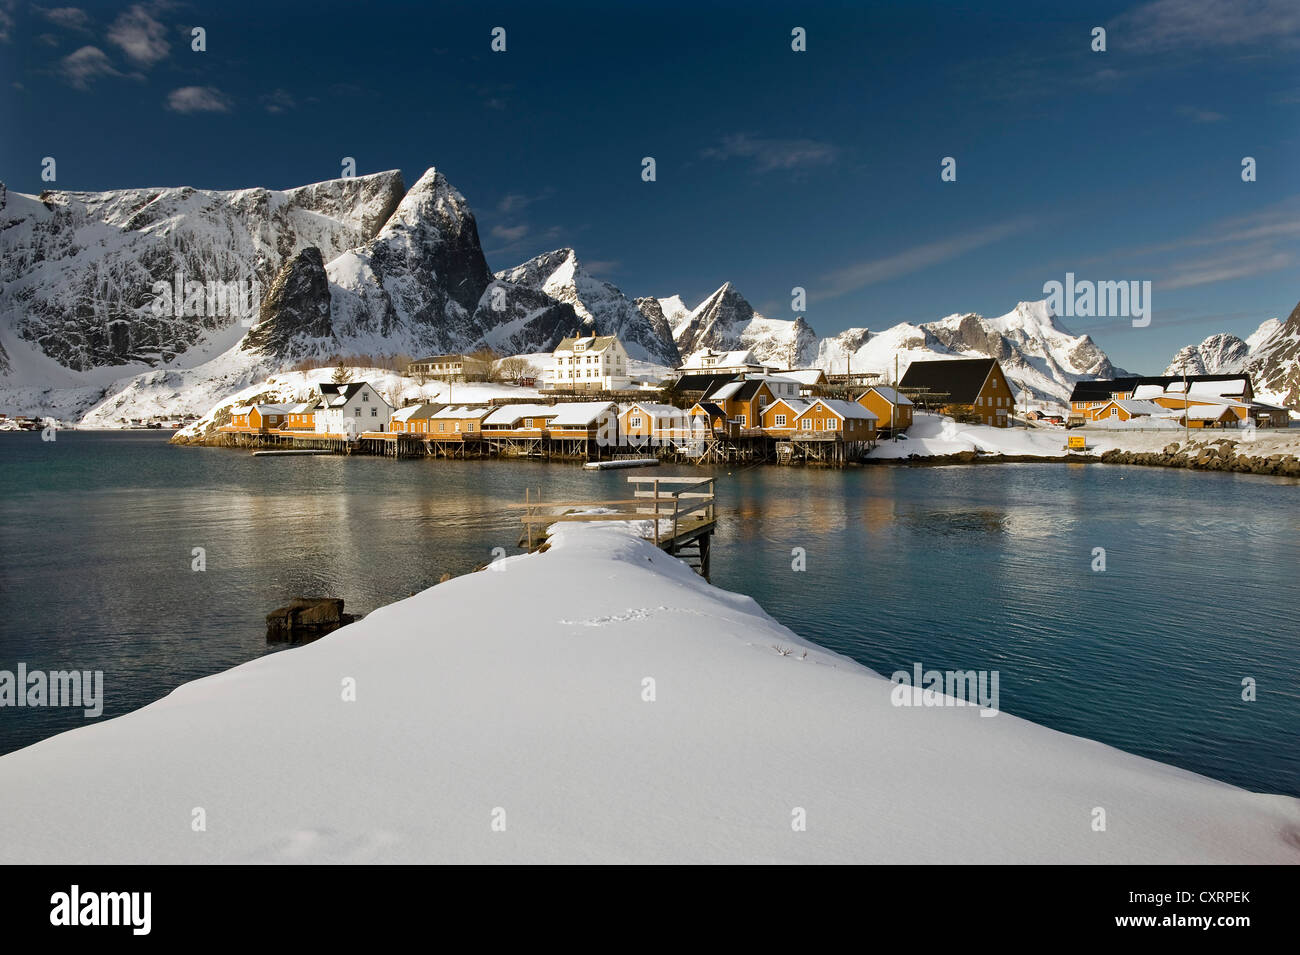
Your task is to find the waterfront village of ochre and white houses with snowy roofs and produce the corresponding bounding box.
[202,328,1290,466]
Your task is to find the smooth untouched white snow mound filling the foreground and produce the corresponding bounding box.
[0,526,1300,863]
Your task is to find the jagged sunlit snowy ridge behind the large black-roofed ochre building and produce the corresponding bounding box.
[816,301,1123,404]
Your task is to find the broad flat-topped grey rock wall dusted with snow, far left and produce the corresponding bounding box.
[0,172,404,370]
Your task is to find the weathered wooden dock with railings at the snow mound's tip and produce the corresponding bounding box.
[520,476,718,578]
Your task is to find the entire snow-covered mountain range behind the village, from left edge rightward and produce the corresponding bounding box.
[0,162,1159,424]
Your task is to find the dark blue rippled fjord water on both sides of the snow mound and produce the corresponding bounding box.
[0,431,1300,795]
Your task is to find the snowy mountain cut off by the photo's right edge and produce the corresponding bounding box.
[1165,297,1300,408]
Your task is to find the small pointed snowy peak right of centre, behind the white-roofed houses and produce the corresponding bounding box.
[659,282,816,368]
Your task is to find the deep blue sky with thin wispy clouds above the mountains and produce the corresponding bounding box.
[0,0,1300,372]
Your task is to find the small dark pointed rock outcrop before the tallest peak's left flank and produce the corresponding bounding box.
[239,247,334,360]
